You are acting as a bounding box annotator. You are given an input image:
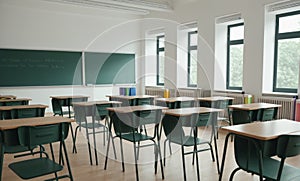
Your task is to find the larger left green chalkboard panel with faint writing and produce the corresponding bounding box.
[0,49,82,87]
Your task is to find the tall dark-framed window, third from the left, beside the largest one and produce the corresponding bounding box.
[226,23,244,90]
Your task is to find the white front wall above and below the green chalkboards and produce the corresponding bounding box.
[0,0,141,112]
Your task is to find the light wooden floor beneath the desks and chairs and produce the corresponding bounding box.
[2,123,300,181]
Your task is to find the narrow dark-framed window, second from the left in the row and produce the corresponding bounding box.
[187,31,198,87]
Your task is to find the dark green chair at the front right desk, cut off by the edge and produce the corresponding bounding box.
[229,135,300,181]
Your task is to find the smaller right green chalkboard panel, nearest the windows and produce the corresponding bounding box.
[84,52,135,85]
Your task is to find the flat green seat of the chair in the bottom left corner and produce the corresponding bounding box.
[8,158,63,179]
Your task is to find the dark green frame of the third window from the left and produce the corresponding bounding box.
[226,23,244,90]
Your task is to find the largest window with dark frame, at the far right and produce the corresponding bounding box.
[273,11,300,93]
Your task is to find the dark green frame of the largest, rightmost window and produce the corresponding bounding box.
[273,10,300,93]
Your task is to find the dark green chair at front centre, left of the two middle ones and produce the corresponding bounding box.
[104,110,164,180]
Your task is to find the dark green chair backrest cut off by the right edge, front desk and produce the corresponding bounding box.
[277,135,300,158]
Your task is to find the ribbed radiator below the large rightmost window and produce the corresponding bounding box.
[256,96,296,120]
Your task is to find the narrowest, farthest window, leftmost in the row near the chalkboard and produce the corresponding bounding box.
[156,35,165,85]
